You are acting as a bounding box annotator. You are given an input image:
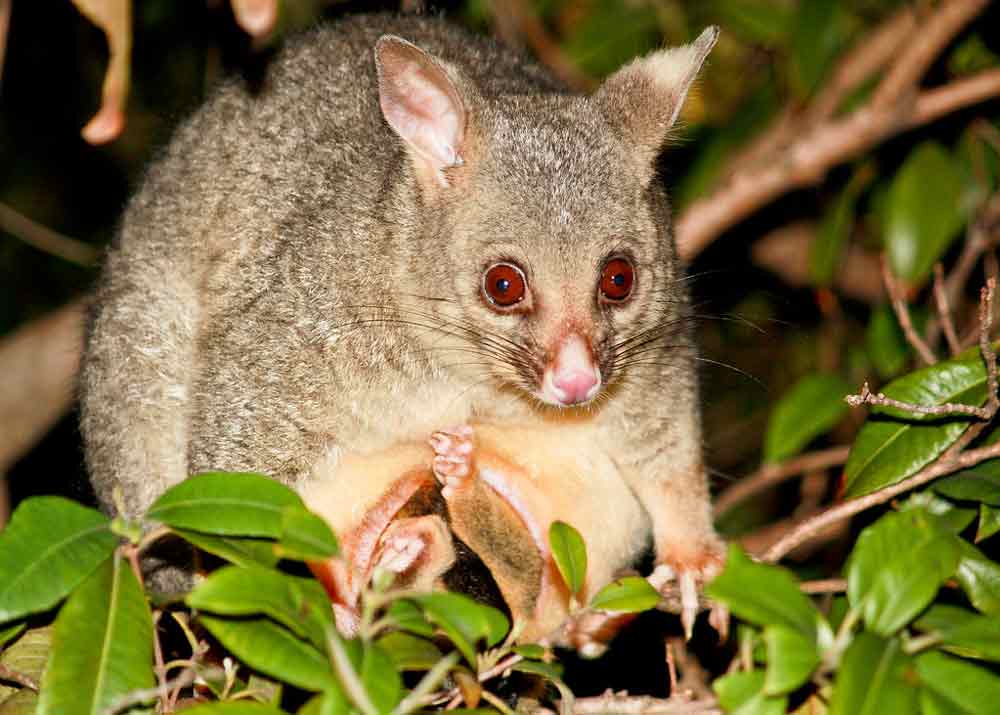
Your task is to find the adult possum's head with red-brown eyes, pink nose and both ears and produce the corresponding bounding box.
[376,28,718,406]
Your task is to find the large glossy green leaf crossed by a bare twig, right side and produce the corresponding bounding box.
[844,351,987,497]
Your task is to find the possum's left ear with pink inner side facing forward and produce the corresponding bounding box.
[375,35,469,186]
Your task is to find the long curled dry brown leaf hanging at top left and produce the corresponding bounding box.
[72,0,132,144]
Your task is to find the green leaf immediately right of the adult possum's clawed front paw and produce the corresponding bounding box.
[705,544,820,642]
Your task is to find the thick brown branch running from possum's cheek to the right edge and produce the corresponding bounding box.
[677,69,1000,259]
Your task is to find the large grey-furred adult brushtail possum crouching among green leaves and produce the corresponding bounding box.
[81,11,721,626]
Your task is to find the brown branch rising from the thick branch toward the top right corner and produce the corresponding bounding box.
[872,0,989,108]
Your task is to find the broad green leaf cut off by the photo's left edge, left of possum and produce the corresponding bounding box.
[0,497,118,623]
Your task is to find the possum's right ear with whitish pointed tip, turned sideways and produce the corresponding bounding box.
[592,26,719,161]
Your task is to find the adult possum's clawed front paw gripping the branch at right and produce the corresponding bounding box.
[648,538,729,640]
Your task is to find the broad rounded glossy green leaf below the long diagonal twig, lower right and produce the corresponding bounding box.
[846,509,961,636]
